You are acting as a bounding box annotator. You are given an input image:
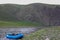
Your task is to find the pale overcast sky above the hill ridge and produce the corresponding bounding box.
[0,0,60,4]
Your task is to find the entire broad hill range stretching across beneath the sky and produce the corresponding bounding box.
[0,3,60,26]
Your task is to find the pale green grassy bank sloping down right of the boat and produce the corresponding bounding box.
[23,27,60,40]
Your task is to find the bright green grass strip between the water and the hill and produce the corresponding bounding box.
[0,21,42,27]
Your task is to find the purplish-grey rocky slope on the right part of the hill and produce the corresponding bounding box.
[17,4,60,26]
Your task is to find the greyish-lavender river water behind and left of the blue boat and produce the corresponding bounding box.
[0,28,38,40]
